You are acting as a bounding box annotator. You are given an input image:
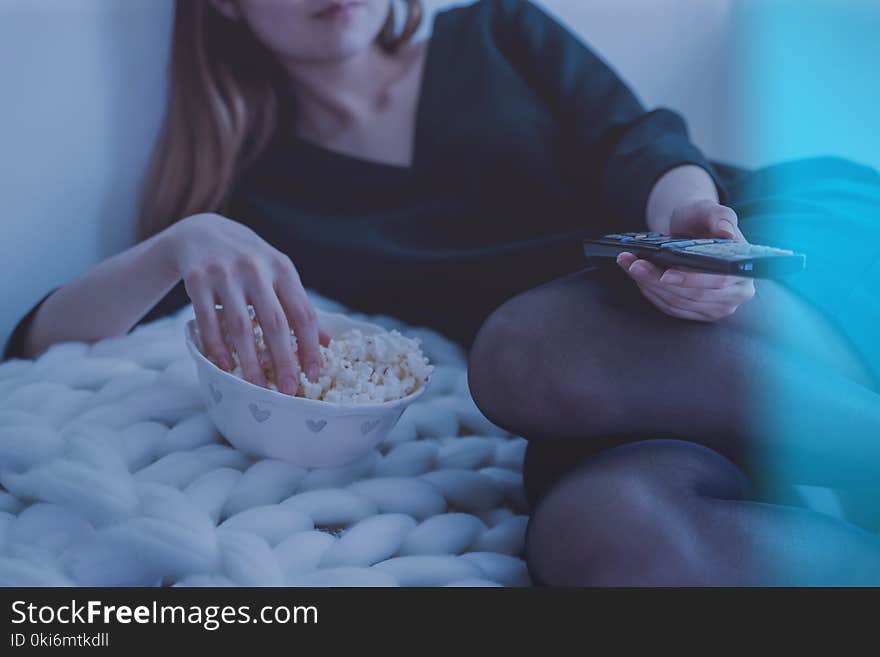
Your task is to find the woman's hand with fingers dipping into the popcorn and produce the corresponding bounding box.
[168,214,330,395]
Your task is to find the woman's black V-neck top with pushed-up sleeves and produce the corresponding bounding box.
[4,0,726,358]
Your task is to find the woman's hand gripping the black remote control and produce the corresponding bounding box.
[617,200,755,322]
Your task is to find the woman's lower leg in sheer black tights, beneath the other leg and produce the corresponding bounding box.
[525,439,880,586]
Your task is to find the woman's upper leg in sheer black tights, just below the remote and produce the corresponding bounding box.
[468,270,880,491]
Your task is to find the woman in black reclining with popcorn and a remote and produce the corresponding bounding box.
[1,0,880,585]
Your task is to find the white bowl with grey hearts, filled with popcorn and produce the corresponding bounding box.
[186,306,434,467]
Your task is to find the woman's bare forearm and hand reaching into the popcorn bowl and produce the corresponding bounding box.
[17,214,326,394]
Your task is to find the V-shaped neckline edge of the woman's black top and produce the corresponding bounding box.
[287,12,445,174]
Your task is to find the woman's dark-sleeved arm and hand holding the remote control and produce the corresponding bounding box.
[492,0,754,321]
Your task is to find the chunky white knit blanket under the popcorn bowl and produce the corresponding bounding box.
[0,292,530,586]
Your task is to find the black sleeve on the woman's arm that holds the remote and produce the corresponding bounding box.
[488,0,726,233]
